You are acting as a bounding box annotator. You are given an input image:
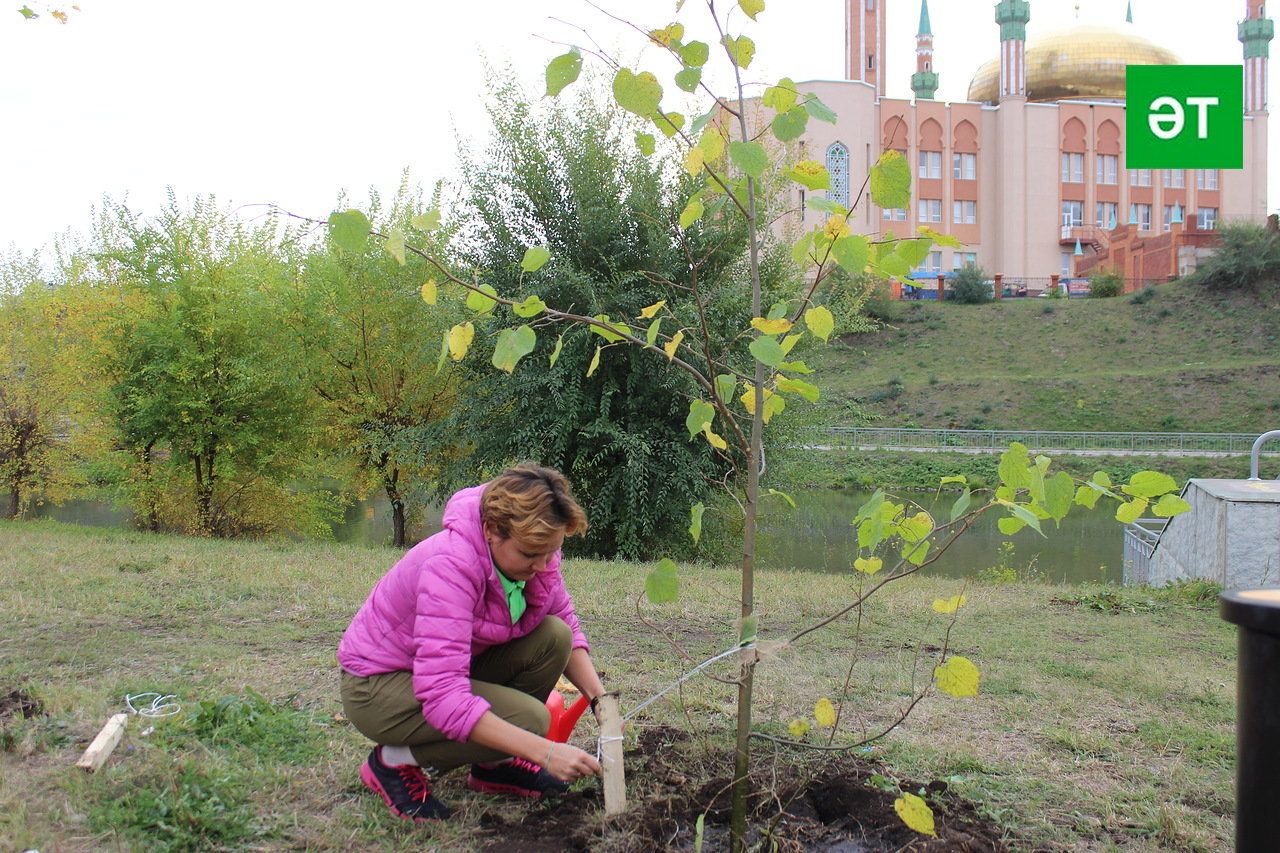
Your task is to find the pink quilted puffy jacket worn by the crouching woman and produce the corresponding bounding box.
[338,485,588,740]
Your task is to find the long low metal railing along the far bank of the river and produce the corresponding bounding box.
[823,427,1280,455]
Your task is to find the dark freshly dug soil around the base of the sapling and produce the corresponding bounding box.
[480,727,1010,853]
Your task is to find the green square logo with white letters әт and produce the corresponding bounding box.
[1125,65,1244,169]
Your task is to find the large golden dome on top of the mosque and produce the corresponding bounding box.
[969,27,1179,104]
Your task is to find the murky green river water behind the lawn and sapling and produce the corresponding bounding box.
[36,489,1124,583]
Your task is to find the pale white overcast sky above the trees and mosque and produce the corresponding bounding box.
[0,0,1280,250]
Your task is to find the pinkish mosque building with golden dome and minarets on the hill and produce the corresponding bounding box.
[792,0,1274,280]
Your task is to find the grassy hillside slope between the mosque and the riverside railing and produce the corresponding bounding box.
[812,283,1280,433]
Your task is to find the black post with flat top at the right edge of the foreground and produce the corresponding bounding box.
[1219,589,1280,853]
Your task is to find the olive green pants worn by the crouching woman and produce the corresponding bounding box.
[342,616,573,775]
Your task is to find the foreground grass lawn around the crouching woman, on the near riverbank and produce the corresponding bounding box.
[0,522,1235,852]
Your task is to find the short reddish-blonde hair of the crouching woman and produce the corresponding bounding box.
[480,462,586,548]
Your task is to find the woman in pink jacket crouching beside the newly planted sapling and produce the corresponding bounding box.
[338,464,604,820]
